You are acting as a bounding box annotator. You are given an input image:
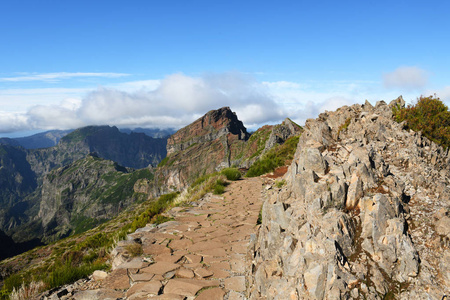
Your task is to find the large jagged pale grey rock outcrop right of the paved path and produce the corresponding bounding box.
[248,98,450,299]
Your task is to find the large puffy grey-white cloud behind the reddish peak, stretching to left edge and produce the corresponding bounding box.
[0,73,286,132]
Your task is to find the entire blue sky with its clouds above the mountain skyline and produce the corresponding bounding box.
[0,0,450,136]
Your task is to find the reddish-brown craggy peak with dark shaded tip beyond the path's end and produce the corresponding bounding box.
[157,107,249,190]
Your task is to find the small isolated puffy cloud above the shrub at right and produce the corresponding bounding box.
[383,66,428,90]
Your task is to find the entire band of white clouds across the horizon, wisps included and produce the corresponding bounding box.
[0,67,450,134]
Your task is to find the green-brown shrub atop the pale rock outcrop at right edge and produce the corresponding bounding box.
[393,96,450,149]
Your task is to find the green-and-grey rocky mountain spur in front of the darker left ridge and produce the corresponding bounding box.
[35,155,153,242]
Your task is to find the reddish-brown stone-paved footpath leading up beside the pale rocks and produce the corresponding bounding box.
[42,178,263,300]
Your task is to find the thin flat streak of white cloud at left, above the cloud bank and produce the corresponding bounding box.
[0,72,129,82]
